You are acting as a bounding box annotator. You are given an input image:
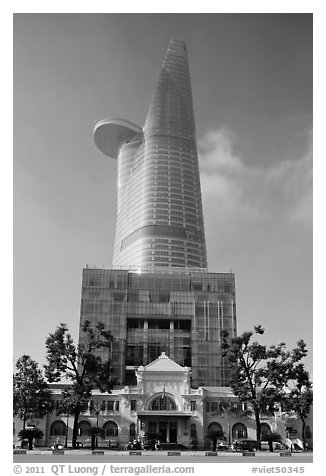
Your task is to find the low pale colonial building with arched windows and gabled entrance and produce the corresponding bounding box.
[14,353,312,449]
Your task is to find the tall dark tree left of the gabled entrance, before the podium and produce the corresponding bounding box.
[44,321,114,448]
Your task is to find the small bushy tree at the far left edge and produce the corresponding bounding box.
[13,355,51,430]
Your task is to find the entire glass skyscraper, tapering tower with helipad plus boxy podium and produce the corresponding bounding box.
[80,40,236,387]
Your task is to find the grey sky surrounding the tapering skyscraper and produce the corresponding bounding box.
[13,13,313,372]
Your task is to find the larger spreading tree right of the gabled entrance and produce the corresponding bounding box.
[221,325,307,445]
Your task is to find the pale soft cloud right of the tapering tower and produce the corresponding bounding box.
[198,127,312,229]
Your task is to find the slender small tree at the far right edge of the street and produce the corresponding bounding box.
[283,363,313,451]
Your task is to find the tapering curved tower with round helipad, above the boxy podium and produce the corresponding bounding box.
[94,40,207,270]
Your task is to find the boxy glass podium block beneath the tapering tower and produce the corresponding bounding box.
[80,268,236,386]
